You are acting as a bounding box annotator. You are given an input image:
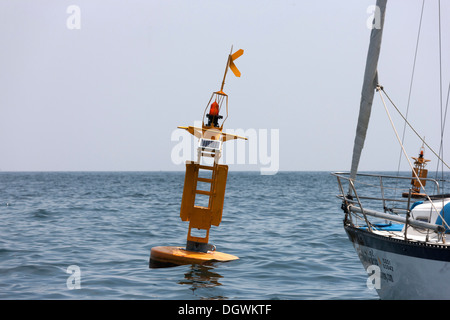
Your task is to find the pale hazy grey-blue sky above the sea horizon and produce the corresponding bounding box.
[0,0,450,171]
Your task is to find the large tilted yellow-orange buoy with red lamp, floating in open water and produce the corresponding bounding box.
[149,49,247,268]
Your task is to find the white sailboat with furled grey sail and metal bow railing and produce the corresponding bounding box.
[333,0,450,300]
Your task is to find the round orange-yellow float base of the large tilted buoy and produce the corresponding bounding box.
[150,246,239,267]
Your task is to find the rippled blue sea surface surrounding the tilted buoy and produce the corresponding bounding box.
[0,172,394,300]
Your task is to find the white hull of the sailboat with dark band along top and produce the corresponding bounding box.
[345,226,450,300]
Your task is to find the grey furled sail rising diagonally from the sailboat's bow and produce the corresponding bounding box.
[349,0,387,192]
